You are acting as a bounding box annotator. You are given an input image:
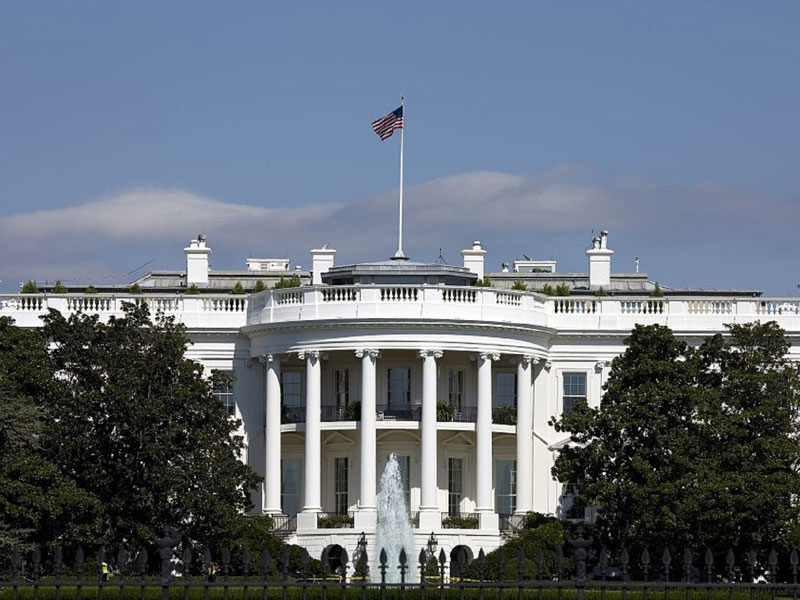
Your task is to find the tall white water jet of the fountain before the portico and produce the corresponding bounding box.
[370,453,419,583]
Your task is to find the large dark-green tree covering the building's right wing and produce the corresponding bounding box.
[553,323,800,553]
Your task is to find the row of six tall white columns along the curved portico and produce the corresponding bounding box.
[261,348,536,530]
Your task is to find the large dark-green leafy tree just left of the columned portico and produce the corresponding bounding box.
[44,303,260,547]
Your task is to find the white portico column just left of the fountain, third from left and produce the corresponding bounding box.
[355,350,379,531]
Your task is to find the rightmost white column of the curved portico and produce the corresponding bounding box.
[516,356,533,515]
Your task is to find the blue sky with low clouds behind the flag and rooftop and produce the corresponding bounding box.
[0,1,800,295]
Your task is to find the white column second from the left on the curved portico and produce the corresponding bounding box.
[299,351,322,513]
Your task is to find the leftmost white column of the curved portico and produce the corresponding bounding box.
[259,354,281,515]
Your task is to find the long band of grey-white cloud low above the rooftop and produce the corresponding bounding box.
[0,166,799,289]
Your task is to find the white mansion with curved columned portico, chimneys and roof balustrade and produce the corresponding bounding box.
[0,234,800,568]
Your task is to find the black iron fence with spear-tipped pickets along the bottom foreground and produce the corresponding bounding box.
[0,529,800,600]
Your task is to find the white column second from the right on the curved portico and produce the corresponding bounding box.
[475,353,500,529]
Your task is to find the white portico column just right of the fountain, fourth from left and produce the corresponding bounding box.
[419,350,442,531]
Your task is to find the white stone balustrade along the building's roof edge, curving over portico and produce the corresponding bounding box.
[0,285,800,332]
